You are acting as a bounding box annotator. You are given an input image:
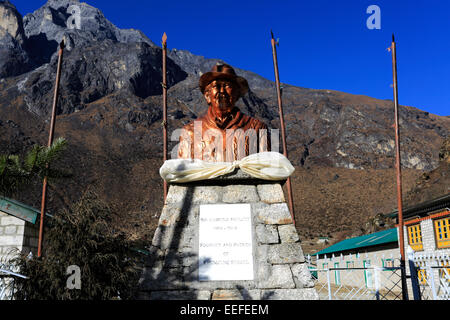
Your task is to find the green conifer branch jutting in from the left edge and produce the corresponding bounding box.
[0,138,70,197]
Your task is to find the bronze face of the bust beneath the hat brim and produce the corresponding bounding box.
[205,79,239,114]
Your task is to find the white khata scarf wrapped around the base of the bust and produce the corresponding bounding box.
[159,152,295,183]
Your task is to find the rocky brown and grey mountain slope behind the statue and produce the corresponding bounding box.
[0,0,450,254]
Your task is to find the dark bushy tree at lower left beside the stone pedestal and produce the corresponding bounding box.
[13,189,139,300]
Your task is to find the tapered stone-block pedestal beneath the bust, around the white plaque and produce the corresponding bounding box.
[140,170,318,300]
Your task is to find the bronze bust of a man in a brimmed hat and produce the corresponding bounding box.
[178,63,270,162]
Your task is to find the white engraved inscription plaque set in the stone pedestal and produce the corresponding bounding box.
[198,204,253,281]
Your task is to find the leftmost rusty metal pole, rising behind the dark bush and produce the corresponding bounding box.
[38,40,64,257]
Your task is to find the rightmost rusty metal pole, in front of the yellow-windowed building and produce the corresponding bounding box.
[391,35,408,300]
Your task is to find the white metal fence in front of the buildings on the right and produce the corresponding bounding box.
[307,250,450,300]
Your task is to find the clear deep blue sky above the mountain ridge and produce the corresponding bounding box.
[11,0,450,116]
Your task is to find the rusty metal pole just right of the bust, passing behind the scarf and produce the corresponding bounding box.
[270,31,295,225]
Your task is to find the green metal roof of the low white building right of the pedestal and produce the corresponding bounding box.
[313,228,398,255]
